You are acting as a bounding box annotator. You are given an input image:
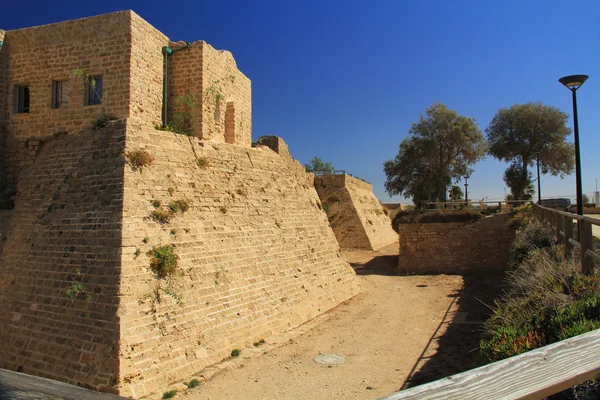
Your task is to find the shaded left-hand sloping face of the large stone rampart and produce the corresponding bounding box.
[0,120,125,391]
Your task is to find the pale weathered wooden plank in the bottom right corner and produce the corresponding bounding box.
[382,329,600,400]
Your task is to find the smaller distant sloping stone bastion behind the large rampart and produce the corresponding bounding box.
[314,175,398,250]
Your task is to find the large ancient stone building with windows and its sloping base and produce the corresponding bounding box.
[0,11,359,398]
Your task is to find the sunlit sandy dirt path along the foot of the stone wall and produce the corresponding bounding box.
[177,244,463,400]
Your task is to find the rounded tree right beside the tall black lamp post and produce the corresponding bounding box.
[486,102,575,200]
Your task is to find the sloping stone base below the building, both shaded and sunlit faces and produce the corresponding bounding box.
[0,122,360,398]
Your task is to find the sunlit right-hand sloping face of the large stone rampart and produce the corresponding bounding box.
[120,128,359,397]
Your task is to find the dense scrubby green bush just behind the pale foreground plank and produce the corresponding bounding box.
[480,246,600,361]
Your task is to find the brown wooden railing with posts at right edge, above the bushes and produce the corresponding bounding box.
[533,204,600,274]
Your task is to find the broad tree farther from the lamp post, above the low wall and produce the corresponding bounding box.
[383,102,487,207]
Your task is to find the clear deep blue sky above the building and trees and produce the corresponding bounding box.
[0,0,600,201]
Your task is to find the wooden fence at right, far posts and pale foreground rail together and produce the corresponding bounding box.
[382,204,600,400]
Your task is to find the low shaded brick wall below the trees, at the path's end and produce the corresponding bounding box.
[398,214,515,274]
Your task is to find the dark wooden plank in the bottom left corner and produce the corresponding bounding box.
[0,369,126,400]
